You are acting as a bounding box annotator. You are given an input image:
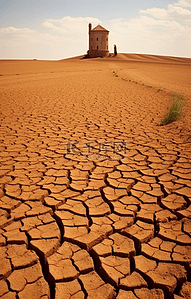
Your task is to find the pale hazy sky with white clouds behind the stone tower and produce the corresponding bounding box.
[0,0,191,60]
